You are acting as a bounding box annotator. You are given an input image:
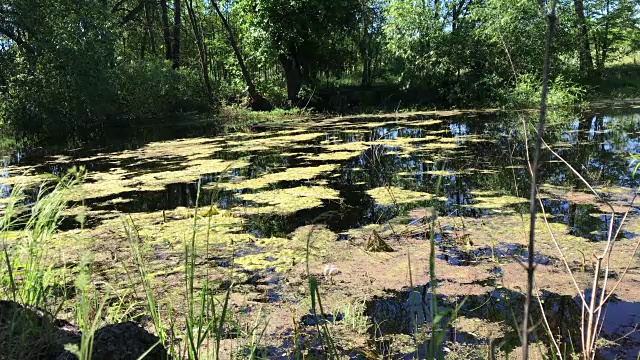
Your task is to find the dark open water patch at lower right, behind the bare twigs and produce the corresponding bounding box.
[365,284,640,360]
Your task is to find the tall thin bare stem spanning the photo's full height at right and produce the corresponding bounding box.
[522,0,558,360]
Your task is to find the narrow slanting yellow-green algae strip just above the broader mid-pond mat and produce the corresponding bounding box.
[215,164,338,190]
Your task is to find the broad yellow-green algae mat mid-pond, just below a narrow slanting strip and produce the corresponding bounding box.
[235,186,340,215]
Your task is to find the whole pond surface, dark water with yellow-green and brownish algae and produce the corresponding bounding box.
[0,106,640,359]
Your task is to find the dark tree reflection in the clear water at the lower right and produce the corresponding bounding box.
[365,286,640,355]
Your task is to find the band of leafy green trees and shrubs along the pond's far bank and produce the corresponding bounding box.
[0,0,640,134]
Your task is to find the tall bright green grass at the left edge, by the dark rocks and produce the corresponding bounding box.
[0,168,102,360]
